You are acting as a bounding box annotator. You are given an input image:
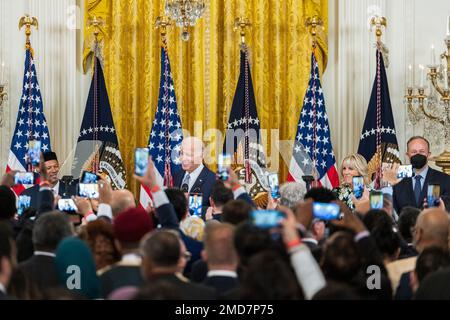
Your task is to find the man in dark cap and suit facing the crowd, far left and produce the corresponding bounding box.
[22,151,77,209]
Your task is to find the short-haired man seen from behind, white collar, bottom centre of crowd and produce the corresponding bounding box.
[202,223,239,295]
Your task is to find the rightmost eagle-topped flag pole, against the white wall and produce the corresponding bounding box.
[370,15,387,189]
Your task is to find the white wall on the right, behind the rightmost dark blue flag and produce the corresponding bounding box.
[323,0,450,168]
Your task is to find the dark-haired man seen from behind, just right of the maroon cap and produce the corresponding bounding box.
[141,229,217,300]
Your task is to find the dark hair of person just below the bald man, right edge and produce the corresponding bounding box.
[416,247,450,282]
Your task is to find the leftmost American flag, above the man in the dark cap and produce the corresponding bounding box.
[6,49,51,194]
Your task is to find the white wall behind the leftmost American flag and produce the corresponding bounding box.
[0,0,89,174]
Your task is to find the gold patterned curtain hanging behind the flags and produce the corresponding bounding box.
[84,0,328,194]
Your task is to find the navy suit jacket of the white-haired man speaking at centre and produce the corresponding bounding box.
[173,166,216,215]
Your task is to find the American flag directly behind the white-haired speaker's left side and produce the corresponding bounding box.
[140,44,183,208]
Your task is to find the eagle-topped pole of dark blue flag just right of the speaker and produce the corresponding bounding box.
[234,17,252,183]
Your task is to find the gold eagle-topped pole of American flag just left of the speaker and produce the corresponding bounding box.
[155,16,173,187]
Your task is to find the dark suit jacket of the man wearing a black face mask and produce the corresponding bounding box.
[393,168,450,213]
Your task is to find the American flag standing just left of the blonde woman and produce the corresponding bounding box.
[288,52,339,188]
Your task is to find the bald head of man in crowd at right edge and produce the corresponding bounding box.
[414,208,450,252]
